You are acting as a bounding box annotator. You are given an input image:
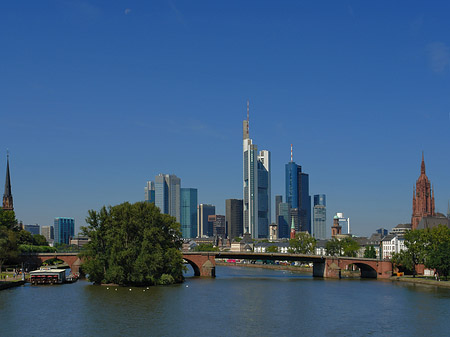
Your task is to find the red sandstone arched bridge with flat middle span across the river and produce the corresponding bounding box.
[22,252,392,279]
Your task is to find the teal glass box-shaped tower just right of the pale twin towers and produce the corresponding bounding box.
[180,188,198,239]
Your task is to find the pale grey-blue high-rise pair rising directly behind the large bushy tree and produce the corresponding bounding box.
[155,174,181,222]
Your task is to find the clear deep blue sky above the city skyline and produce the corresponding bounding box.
[0,0,450,235]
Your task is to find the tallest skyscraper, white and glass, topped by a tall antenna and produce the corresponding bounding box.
[243,101,271,238]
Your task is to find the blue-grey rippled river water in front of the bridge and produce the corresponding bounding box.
[0,266,450,336]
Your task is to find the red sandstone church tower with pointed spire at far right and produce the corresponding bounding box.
[411,152,436,229]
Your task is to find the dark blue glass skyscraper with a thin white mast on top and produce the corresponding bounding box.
[285,145,311,233]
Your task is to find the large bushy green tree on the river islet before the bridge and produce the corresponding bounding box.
[80,202,184,286]
